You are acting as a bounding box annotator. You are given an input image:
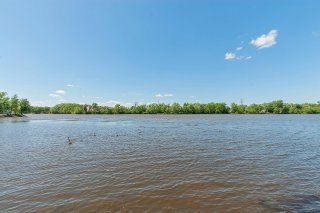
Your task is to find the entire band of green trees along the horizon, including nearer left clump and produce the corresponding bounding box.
[0,92,320,115]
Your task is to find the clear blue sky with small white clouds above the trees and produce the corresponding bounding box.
[0,0,320,106]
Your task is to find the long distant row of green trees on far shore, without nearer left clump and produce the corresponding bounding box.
[46,100,320,114]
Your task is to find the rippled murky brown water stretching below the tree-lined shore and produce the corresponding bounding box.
[0,115,320,212]
